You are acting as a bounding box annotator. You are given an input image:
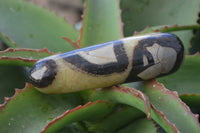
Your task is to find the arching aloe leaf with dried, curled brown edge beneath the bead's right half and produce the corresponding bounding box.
[88,87,178,133]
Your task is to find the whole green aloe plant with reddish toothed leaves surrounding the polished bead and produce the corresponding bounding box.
[0,0,200,133]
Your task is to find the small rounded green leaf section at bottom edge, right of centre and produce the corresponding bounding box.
[116,118,157,133]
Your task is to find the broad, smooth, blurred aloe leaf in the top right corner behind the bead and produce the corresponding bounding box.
[121,0,200,53]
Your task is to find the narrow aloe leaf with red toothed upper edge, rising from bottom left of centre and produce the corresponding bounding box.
[42,100,112,133]
